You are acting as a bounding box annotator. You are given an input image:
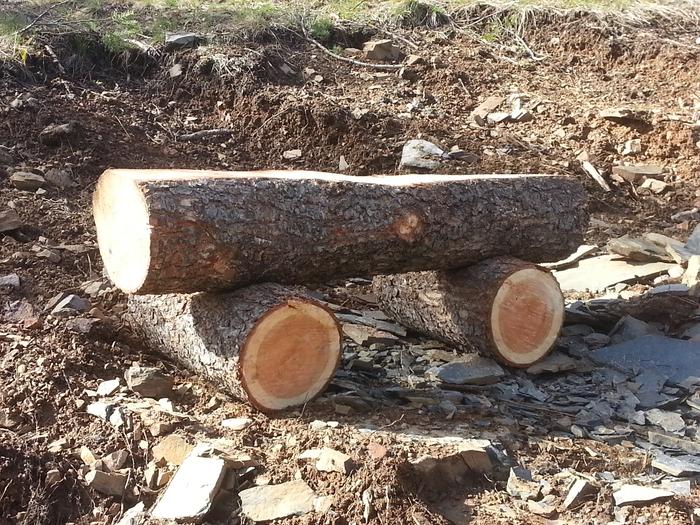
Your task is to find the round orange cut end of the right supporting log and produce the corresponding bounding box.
[491,268,564,367]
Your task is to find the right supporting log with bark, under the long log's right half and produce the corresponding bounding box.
[373,257,564,367]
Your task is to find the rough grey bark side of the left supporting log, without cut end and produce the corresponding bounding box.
[127,283,342,410]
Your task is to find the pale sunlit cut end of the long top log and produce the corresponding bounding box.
[92,171,151,293]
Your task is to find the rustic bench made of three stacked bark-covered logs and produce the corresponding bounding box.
[93,170,588,411]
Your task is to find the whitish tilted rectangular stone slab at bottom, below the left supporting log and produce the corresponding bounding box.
[151,456,226,522]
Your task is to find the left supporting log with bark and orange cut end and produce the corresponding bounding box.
[127,283,342,412]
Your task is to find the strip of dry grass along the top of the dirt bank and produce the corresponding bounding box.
[0,0,700,59]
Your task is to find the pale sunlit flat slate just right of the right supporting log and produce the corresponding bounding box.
[554,254,674,292]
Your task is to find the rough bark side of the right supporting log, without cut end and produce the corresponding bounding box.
[373,257,564,367]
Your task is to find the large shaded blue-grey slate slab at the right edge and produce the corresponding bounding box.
[589,335,700,384]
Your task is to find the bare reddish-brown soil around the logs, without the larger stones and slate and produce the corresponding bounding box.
[0,7,700,525]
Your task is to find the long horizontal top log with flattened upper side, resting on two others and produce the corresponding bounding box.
[93,170,588,294]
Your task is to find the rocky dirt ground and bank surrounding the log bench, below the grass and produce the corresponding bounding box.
[0,5,700,525]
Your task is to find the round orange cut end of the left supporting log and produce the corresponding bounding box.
[240,299,342,411]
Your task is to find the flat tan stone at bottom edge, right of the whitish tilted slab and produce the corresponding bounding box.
[238,480,316,522]
